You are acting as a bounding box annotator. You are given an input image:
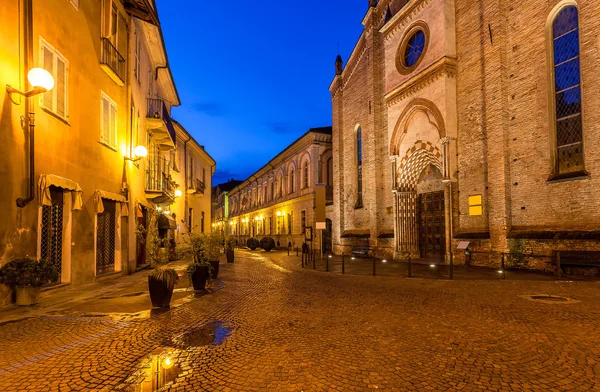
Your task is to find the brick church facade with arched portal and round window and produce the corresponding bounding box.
[330,0,600,268]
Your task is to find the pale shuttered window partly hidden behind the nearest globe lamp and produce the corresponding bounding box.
[40,38,69,120]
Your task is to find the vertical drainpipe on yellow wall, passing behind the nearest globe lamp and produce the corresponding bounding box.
[17,0,35,208]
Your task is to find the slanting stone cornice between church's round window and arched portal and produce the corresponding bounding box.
[385,57,456,107]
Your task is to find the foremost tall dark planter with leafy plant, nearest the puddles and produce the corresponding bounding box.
[136,210,179,308]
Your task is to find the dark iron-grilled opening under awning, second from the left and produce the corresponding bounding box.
[96,199,117,275]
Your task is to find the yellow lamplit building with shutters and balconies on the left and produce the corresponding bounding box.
[0,0,215,303]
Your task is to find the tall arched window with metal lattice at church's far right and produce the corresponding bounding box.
[552,5,584,174]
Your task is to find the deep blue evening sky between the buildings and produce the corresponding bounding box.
[157,0,368,185]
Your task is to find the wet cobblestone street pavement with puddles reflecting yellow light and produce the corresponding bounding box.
[0,251,600,391]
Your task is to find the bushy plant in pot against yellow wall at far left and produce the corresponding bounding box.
[0,258,58,305]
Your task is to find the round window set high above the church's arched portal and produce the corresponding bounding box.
[396,22,429,75]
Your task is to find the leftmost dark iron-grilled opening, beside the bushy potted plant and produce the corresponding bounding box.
[40,186,63,279]
